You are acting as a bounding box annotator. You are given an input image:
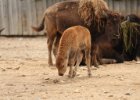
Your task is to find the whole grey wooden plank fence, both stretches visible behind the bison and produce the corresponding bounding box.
[0,0,140,36]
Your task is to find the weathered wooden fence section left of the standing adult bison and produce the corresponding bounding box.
[0,0,62,36]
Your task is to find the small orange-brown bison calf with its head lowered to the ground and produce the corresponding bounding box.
[56,26,91,78]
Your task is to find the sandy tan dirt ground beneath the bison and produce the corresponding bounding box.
[0,37,140,100]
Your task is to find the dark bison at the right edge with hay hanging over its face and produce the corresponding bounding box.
[121,14,140,60]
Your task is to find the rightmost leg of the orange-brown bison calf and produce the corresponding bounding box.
[85,49,91,77]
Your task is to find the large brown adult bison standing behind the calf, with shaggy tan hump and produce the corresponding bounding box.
[32,0,120,65]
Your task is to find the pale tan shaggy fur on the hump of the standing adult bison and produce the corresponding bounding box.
[78,0,109,26]
